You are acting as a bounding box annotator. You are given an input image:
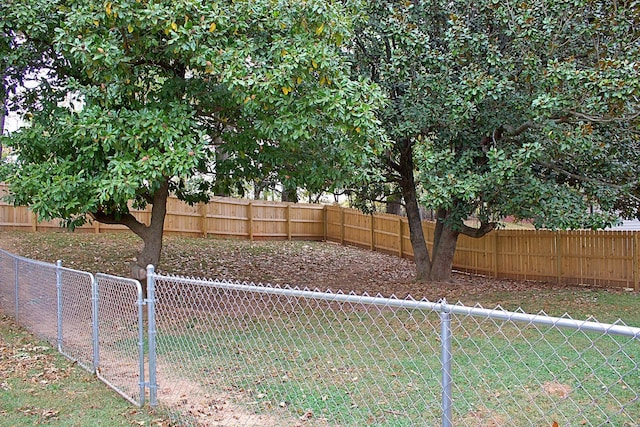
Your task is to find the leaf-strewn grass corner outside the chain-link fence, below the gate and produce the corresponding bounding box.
[0,315,166,427]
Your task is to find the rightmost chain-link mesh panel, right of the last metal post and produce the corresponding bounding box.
[452,310,640,426]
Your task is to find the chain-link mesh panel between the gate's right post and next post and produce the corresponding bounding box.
[156,278,440,426]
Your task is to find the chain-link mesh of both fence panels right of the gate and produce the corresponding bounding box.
[151,277,640,426]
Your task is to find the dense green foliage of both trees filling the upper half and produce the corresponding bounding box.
[0,0,640,280]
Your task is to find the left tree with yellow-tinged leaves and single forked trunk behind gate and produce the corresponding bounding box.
[2,0,376,279]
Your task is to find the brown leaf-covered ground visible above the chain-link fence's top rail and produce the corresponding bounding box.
[0,231,637,321]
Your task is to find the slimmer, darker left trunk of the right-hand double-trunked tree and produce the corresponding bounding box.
[399,141,431,281]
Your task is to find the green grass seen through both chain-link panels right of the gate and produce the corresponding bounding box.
[151,307,640,426]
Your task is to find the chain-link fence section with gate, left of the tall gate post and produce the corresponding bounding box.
[0,250,146,406]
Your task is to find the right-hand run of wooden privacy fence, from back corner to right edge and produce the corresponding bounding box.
[325,206,640,291]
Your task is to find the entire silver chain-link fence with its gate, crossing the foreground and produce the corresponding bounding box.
[0,251,640,426]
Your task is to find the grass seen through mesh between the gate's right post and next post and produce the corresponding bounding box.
[158,310,439,426]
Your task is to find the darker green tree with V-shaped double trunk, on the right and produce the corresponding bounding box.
[352,0,640,281]
